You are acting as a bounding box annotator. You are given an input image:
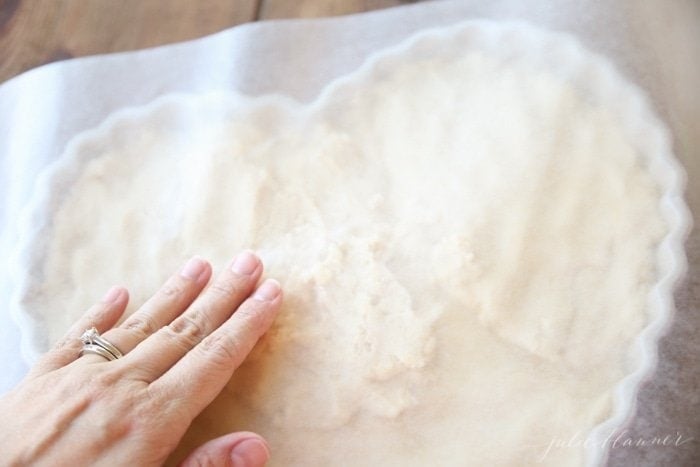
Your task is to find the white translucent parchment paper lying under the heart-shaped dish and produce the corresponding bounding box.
[0,0,700,466]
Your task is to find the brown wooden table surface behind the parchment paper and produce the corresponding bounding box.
[0,0,411,83]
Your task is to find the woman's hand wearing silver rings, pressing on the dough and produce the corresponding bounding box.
[0,252,282,467]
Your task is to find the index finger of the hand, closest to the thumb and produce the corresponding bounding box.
[151,279,282,417]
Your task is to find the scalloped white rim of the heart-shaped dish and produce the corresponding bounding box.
[9,20,692,465]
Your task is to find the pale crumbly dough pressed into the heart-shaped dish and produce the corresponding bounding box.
[24,32,664,467]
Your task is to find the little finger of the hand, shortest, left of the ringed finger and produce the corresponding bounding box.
[32,287,129,374]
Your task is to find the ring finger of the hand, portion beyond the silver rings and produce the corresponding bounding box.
[96,256,211,358]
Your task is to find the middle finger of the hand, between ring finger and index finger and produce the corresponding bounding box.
[125,251,262,383]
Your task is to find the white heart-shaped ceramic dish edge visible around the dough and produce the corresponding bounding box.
[12,21,690,465]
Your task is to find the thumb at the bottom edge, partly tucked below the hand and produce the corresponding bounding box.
[180,431,270,467]
